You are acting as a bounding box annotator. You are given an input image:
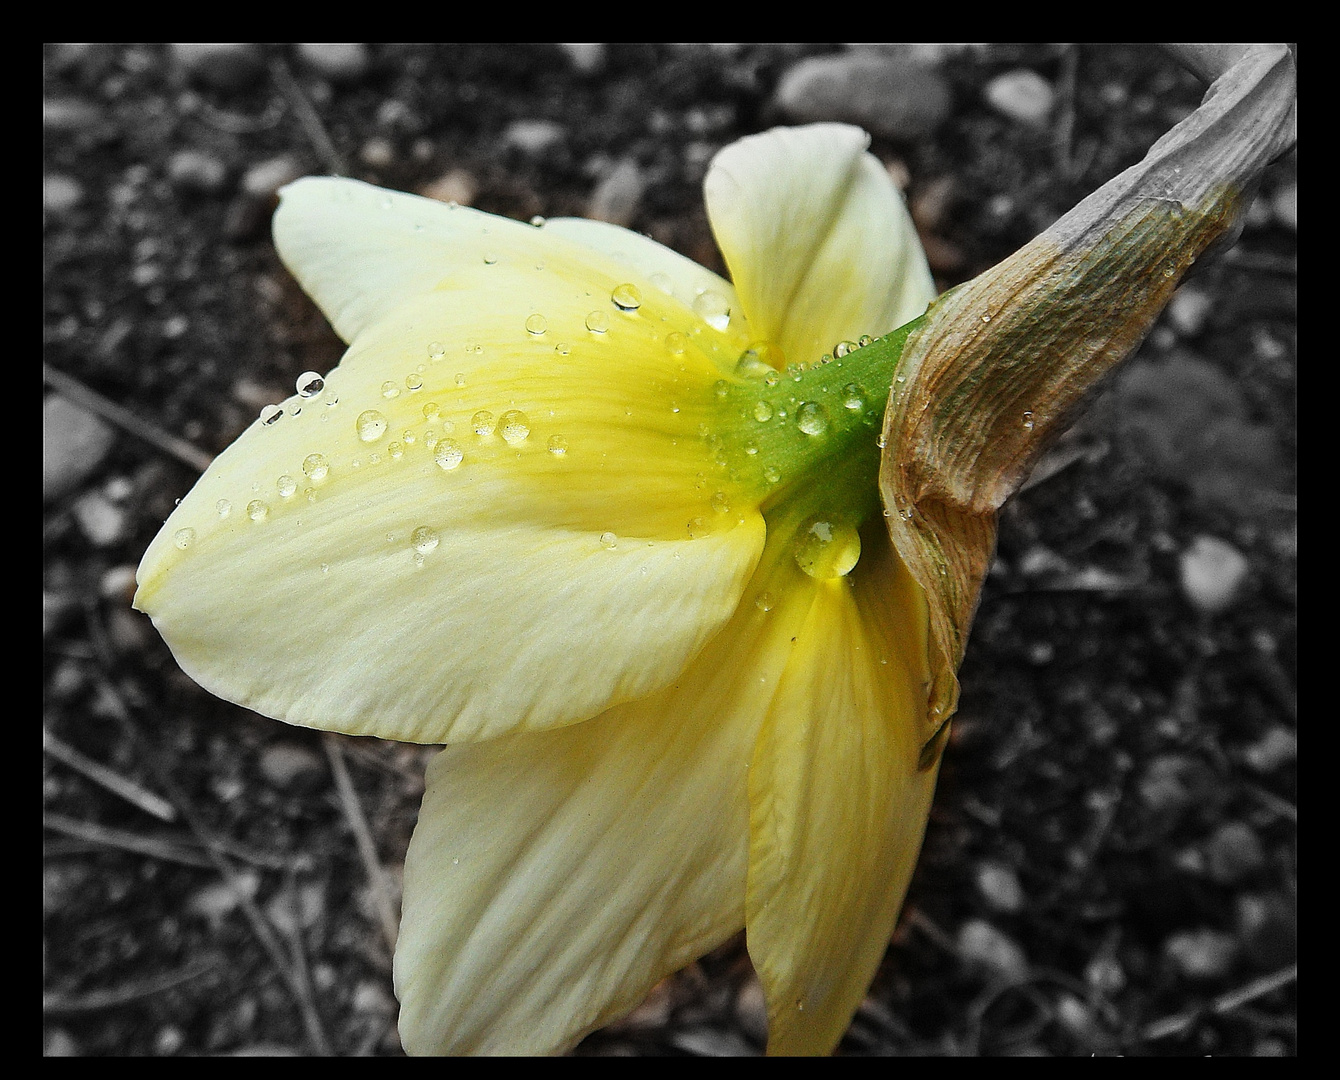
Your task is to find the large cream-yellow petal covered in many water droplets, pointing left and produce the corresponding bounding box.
[137,238,764,742]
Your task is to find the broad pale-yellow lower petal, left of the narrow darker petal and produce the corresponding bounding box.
[395,535,805,1053]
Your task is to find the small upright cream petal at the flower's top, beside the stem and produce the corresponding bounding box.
[704,123,935,363]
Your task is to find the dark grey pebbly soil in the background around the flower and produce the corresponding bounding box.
[43,44,1297,1056]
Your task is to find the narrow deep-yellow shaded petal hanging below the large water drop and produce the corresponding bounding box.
[746,520,935,1055]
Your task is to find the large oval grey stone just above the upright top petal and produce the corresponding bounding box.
[776,52,953,142]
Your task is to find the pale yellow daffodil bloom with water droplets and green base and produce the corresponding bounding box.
[135,125,935,1053]
